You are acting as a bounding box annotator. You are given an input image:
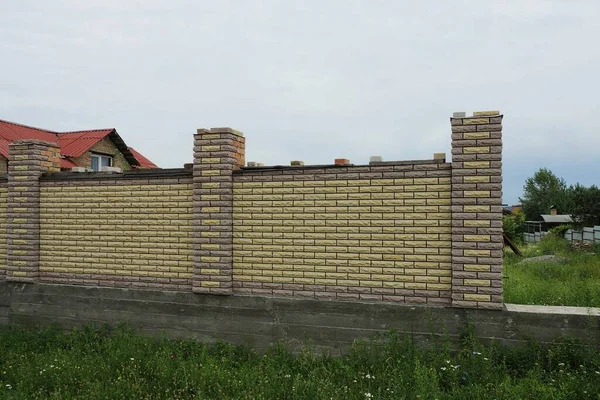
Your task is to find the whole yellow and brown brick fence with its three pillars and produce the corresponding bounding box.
[0,112,503,309]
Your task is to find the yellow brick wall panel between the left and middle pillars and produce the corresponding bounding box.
[40,178,193,290]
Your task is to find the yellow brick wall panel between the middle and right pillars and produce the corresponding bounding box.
[233,169,451,302]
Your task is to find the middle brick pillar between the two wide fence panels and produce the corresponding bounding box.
[192,128,246,294]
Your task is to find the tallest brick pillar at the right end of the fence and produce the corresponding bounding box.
[450,111,503,309]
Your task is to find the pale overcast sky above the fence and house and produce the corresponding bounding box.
[0,0,600,204]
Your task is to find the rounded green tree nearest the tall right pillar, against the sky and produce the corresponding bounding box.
[519,168,571,221]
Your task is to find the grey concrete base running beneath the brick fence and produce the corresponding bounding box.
[0,282,600,351]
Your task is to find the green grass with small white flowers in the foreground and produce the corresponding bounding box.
[0,327,600,400]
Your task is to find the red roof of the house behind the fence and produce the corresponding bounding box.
[0,120,158,168]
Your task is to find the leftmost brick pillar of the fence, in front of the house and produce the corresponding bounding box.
[6,140,60,282]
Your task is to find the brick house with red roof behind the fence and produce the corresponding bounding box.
[0,120,158,174]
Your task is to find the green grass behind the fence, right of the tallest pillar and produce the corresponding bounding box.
[504,236,600,307]
